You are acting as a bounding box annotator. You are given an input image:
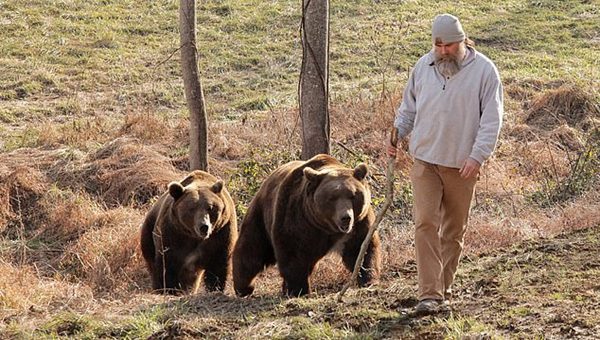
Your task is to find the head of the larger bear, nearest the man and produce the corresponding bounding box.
[303,163,371,234]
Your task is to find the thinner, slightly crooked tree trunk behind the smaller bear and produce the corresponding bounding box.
[179,0,208,171]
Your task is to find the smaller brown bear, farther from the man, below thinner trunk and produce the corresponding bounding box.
[140,170,238,294]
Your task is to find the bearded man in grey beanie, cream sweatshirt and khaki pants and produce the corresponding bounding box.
[387,14,503,314]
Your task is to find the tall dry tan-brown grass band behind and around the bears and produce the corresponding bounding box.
[0,80,600,337]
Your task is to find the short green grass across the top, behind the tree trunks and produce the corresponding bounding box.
[0,0,600,126]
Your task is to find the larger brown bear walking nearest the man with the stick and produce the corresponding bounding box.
[233,155,380,296]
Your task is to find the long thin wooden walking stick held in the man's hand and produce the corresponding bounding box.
[338,127,398,302]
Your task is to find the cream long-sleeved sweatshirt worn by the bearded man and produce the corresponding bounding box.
[394,48,503,168]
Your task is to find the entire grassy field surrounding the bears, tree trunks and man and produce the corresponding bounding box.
[0,0,600,339]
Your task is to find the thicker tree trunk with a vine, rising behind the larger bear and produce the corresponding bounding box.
[300,0,330,159]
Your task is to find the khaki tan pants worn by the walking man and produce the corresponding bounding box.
[410,160,477,300]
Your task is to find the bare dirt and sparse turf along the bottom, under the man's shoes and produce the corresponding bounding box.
[129,226,600,339]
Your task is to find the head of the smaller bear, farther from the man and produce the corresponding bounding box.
[169,180,225,240]
